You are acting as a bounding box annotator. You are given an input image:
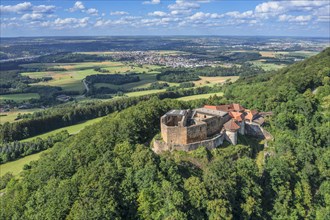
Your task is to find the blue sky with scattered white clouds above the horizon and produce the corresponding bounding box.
[0,0,330,37]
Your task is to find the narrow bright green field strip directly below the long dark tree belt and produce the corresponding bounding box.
[22,117,104,141]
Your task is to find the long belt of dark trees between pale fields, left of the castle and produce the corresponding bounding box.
[0,86,219,143]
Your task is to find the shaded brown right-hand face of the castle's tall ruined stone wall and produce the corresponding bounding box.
[181,123,207,144]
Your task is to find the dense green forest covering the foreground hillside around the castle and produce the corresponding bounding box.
[0,48,330,220]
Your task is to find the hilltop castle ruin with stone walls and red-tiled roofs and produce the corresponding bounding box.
[153,104,269,153]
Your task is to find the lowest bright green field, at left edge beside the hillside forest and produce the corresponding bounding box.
[0,149,49,177]
